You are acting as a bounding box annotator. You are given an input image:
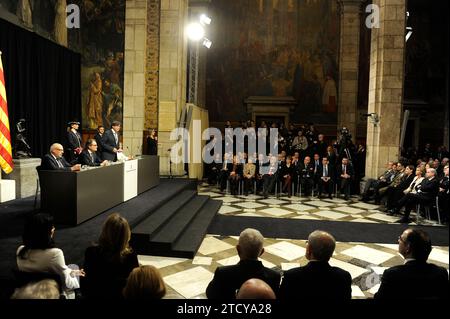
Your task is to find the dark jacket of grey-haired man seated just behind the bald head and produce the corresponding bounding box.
[206,260,281,299]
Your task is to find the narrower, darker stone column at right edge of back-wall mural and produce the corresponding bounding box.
[338,0,363,137]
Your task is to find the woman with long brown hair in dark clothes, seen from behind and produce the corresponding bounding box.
[81,213,139,299]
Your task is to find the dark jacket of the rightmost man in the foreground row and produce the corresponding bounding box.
[375,260,449,299]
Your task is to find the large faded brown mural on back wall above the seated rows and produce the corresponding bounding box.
[206,0,339,124]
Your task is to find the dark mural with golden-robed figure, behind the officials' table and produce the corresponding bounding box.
[69,0,125,129]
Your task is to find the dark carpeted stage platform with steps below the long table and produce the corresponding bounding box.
[0,178,222,300]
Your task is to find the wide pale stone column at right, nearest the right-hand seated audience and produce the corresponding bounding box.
[366,0,406,178]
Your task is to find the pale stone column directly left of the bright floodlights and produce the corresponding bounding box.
[158,0,188,175]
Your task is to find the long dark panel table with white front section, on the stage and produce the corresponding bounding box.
[39,156,159,225]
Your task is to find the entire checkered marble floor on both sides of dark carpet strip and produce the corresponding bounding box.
[135,185,449,299]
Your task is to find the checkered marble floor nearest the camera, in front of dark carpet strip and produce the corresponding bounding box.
[139,234,449,299]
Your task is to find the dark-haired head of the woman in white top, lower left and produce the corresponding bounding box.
[20,213,54,257]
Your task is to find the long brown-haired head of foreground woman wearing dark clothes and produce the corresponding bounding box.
[98,213,131,257]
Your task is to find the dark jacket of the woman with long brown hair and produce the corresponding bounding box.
[80,246,139,299]
